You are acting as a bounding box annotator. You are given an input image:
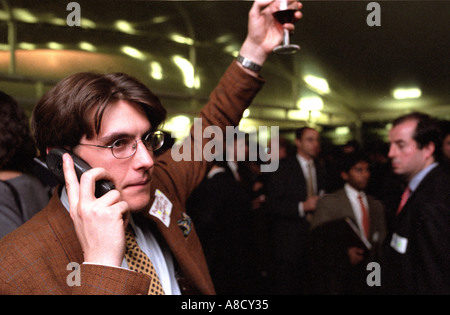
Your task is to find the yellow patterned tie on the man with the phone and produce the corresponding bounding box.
[125,225,164,295]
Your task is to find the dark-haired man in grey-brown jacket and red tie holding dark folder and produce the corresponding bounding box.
[309,153,386,294]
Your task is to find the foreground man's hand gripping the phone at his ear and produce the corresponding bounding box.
[57,153,130,267]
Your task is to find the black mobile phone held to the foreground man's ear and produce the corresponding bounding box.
[46,148,115,198]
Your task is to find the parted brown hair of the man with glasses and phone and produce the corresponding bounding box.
[32,72,166,156]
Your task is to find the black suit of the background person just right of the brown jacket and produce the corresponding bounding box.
[187,163,257,294]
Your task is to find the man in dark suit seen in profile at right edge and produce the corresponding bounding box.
[382,112,450,294]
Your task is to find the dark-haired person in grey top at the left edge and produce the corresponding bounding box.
[0,91,49,238]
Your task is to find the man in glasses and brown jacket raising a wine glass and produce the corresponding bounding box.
[0,0,301,294]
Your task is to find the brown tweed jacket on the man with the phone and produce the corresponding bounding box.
[0,62,263,294]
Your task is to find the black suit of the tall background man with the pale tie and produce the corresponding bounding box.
[266,156,325,294]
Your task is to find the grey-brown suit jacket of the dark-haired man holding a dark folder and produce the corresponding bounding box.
[309,189,386,294]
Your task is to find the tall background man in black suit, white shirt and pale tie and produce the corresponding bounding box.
[267,127,325,294]
